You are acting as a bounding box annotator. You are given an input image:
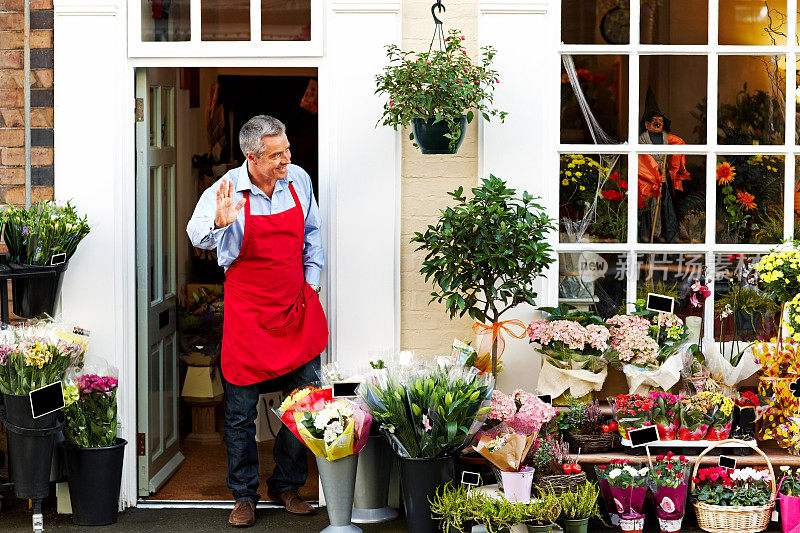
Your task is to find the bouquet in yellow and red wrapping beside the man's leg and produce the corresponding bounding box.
[277,387,372,461]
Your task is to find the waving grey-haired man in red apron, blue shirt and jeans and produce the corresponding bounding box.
[187,115,328,526]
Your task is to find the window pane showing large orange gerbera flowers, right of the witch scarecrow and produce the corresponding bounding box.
[717,155,784,244]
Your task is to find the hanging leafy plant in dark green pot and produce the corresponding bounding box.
[375,30,506,154]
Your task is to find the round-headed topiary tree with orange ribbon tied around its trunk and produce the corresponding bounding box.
[411,175,555,375]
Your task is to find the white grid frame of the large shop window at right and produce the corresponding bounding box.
[546,0,800,345]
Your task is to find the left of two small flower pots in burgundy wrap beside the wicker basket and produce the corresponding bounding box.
[604,459,649,533]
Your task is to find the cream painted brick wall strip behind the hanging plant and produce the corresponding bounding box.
[401,0,478,355]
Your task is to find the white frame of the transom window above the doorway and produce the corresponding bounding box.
[128,0,324,58]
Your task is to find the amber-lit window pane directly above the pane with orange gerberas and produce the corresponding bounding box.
[716,56,786,144]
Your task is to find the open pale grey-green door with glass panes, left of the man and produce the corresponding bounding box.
[136,69,183,496]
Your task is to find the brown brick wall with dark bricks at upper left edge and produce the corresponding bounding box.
[0,0,53,205]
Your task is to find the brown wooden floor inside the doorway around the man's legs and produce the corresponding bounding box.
[144,440,319,501]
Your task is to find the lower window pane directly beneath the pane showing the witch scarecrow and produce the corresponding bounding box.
[636,254,705,317]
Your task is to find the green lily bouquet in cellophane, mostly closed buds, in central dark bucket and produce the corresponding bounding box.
[358,362,494,457]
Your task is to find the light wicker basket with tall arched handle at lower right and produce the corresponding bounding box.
[690,439,775,533]
